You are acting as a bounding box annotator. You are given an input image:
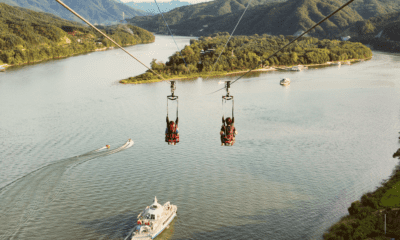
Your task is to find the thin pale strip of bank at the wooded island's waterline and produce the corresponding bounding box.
[119,57,372,84]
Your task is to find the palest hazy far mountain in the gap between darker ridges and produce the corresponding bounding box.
[124,0,190,15]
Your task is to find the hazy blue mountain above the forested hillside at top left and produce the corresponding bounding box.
[0,0,146,24]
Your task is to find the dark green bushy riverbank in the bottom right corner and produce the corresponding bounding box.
[323,144,400,240]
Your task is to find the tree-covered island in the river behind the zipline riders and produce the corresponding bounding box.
[120,33,372,83]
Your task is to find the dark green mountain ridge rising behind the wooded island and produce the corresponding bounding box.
[128,0,363,37]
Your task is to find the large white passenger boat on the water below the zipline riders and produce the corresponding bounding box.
[132,197,178,240]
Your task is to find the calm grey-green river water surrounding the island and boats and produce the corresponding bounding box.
[0,36,400,240]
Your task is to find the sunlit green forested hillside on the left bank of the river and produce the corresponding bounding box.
[0,3,155,65]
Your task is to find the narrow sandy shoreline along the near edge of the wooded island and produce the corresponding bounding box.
[118,57,372,84]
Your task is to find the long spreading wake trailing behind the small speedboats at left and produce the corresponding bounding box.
[0,139,134,240]
